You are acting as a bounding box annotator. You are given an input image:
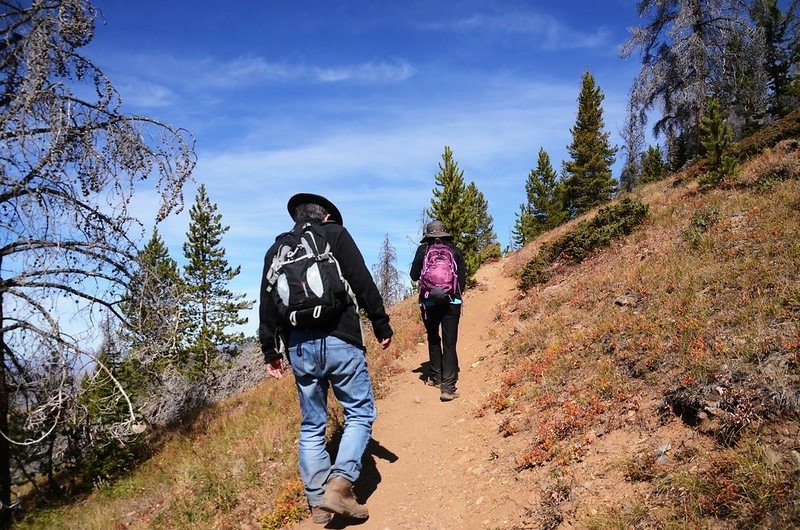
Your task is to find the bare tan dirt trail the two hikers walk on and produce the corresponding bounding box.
[294,262,520,530]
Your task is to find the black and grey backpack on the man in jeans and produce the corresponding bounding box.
[266,223,356,328]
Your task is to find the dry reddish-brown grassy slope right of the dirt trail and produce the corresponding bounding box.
[488,141,800,528]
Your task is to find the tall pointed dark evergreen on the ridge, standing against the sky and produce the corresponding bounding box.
[564,70,617,217]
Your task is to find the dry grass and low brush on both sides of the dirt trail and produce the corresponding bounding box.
[18,116,800,529]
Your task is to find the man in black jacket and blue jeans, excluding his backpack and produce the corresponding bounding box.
[258,193,393,524]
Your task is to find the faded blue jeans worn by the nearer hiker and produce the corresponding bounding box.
[288,330,376,506]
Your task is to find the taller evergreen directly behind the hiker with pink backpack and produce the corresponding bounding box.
[428,146,481,284]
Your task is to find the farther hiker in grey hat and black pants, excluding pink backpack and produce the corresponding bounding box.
[410,221,467,401]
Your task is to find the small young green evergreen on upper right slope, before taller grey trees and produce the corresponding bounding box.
[700,99,736,187]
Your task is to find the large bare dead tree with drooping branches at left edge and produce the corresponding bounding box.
[0,0,195,525]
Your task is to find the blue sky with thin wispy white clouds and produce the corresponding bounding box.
[84,0,639,334]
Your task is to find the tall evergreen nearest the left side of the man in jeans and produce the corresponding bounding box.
[183,185,253,376]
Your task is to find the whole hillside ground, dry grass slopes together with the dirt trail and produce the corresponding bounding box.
[20,137,800,529]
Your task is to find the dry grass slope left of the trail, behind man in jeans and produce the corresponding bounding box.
[17,292,423,530]
